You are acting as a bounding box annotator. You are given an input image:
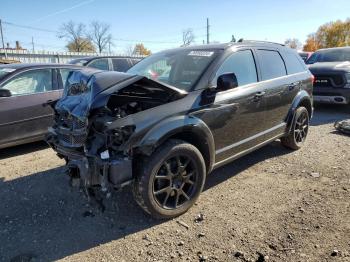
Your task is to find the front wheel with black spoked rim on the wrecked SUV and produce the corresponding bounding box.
[133,139,206,219]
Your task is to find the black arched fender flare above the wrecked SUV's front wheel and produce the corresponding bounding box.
[135,115,215,172]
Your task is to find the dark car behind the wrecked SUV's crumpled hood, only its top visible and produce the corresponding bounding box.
[69,56,141,72]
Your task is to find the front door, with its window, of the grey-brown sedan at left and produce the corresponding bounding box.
[0,68,60,146]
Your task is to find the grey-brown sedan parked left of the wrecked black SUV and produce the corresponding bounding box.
[0,64,93,148]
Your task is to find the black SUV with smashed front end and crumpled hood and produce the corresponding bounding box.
[47,41,312,218]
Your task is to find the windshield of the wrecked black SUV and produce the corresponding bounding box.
[127,49,217,91]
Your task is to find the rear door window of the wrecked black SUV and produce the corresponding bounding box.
[257,50,287,80]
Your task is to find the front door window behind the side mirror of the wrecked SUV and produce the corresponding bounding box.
[214,50,257,86]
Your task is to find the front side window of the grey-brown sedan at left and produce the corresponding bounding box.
[2,69,52,95]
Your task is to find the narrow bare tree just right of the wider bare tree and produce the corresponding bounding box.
[89,21,112,53]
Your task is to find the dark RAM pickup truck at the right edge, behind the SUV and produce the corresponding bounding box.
[306,47,350,104]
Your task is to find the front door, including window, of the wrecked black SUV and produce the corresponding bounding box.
[197,49,265,163]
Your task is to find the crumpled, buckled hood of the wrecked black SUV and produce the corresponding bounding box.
[55,70,187,120]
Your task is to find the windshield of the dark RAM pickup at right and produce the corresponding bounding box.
[306,48,350,64]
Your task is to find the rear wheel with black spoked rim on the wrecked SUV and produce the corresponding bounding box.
[281,106,310,150]
